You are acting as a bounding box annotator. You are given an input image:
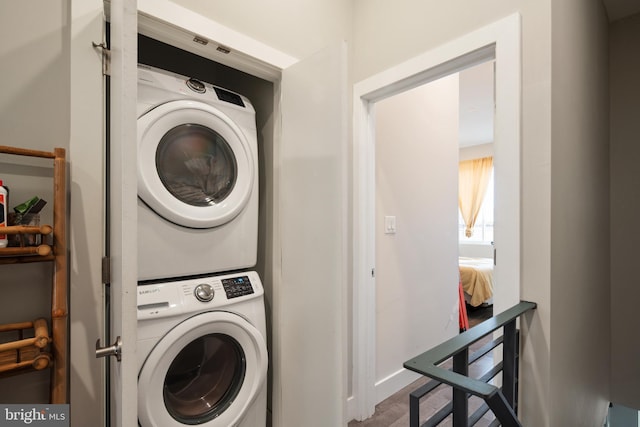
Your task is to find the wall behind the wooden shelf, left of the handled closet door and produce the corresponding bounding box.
[0,0,103,425]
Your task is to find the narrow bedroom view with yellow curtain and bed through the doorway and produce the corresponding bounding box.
[458,61,500,326]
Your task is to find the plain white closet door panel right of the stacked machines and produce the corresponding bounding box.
[273,44,348,427]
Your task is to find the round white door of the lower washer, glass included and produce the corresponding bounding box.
[138,311,267,427]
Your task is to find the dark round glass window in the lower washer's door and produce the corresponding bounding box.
[163,333,246,425]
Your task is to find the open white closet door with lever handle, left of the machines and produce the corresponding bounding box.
[103,0,138,427]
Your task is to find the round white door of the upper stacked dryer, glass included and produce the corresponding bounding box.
[138,100,257,228]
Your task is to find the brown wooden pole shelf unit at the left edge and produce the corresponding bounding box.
[0,145,69,404]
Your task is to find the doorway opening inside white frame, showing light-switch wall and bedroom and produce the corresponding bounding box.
[374,60,494,408]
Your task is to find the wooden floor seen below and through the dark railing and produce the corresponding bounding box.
[349,307,494,427]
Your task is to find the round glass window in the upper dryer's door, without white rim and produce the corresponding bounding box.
[156,123,237,206]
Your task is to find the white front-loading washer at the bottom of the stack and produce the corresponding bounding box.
[137,271,268,427]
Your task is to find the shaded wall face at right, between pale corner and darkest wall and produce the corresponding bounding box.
[549,0,608,426]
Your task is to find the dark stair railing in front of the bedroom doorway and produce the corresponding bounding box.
[404,301,536,427]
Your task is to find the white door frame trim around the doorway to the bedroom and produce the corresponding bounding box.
[348,13,521,420]
